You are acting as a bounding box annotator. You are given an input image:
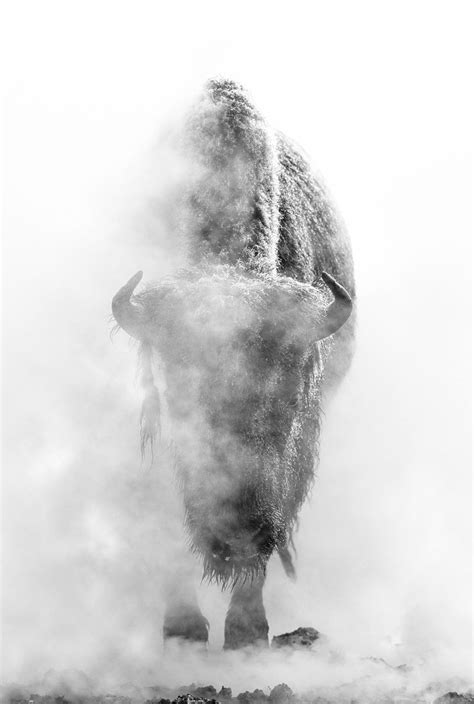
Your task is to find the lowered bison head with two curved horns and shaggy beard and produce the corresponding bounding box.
[112,265,351,583]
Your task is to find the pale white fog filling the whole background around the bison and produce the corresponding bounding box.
[2,2,473,690]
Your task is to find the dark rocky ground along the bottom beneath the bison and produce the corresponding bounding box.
[0,627,474,704]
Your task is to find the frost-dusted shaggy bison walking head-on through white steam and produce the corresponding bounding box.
[112,80,355,649]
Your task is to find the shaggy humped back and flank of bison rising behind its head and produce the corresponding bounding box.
[185,80,354,302]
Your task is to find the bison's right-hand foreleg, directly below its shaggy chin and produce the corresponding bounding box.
[224,576,268,650]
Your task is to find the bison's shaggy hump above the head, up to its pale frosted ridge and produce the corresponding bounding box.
[180,80,279,274]
